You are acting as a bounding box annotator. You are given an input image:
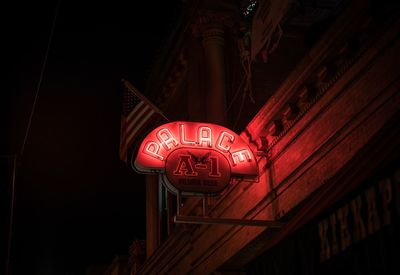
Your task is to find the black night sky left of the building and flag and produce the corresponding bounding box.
[0,0,182,274]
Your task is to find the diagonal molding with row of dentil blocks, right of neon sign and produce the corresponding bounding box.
[242,12,382,161]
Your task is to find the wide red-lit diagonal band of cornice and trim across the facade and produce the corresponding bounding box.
[139,1,400,274]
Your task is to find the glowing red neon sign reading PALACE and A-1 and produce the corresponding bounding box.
[134,121,258,193]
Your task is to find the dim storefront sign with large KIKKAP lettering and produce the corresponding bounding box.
[318,168,400,262]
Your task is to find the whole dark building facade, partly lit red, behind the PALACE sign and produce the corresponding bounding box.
[131,0,400,274]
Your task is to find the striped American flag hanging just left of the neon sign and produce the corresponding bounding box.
[119,79,168,163]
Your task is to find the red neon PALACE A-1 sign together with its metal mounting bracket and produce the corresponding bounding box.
[136,121,276,228]
